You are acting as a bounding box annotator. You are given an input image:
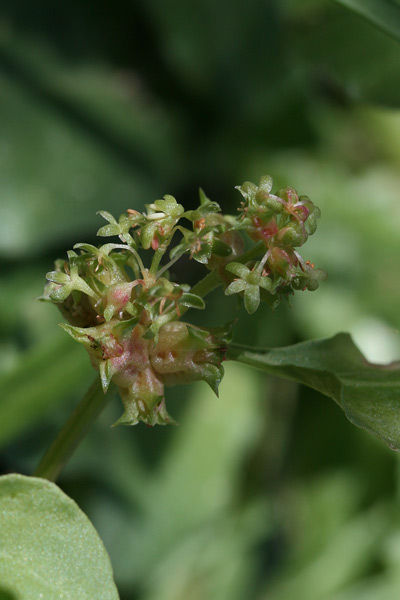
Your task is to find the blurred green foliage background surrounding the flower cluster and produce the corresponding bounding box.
[0,0,400,600]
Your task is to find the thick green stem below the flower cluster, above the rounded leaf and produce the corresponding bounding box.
[33,378,112,481]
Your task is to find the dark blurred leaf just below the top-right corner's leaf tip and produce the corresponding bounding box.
[291,3,400,107]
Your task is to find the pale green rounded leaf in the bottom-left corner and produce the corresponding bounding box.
[0,475,118,600]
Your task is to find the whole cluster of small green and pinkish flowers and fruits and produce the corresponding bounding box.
[42,177,324,425]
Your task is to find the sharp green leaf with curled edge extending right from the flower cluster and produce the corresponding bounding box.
[227,333,400,450]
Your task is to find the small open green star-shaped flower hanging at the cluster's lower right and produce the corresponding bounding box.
[225,262,273,314]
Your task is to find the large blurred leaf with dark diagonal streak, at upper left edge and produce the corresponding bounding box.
[0,38,176,259]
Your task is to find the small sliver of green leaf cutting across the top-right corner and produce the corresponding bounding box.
[336,0,400,41]
